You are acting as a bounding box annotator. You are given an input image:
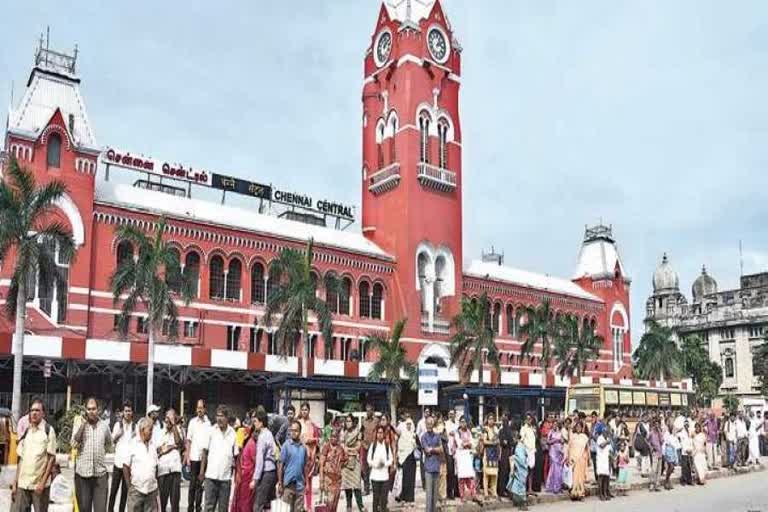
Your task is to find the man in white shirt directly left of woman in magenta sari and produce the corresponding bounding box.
[198,405,239,512]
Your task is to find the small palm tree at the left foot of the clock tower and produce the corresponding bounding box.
[368,320,418,421]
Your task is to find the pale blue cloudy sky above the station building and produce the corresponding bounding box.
[0,0,768,344]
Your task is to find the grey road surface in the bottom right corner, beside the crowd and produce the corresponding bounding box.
[529,471,768,512]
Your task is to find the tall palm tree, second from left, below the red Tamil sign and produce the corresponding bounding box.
[110,218,196,409]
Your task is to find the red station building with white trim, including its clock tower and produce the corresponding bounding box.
[0,0,631,420]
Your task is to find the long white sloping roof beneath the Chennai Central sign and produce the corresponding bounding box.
[96,182,394,260]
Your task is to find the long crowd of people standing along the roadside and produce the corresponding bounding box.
[7,398,768,512]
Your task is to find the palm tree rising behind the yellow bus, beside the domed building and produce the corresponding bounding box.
[632,321,682,380]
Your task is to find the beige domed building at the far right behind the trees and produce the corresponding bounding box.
[645,254,768,409]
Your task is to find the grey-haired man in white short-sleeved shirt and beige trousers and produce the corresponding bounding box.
[123,418,157,512]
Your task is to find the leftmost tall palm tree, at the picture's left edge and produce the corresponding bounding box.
[0,156,75,420]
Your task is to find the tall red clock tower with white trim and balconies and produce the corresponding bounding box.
[362,0,463,339]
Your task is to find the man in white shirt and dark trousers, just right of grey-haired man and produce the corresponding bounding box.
[153,409,184,512]
